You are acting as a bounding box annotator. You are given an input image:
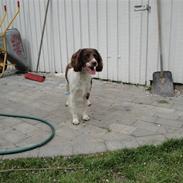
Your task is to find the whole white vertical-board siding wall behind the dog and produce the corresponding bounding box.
[0,0,183,84]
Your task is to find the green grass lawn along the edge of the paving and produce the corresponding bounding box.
[0,139,183,183]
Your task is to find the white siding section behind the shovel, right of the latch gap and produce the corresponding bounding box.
[147,0,183,83]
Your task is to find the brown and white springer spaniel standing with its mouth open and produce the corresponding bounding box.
[65,48,103,125]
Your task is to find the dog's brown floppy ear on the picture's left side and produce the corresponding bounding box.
[71,49,83,72]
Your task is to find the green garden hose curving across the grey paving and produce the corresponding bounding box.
[0,113,55,155]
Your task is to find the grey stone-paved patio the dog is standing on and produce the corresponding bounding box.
[0,75,183,159]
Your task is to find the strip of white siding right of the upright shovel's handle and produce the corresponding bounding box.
[162,0,183,83]
